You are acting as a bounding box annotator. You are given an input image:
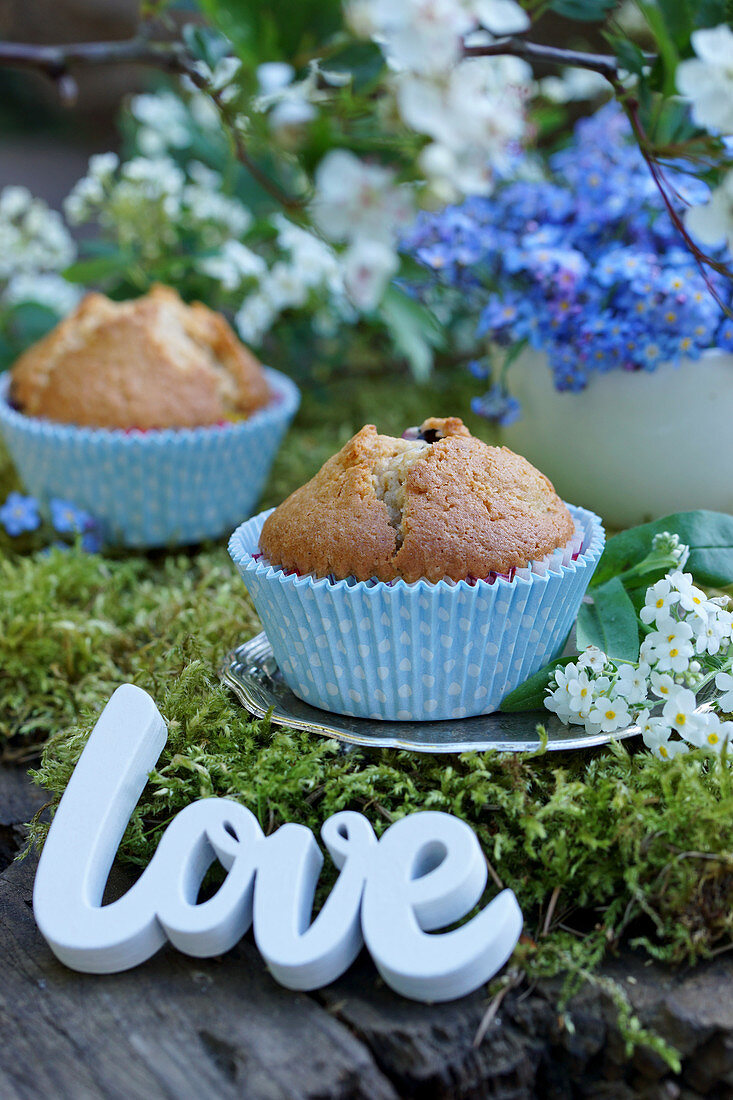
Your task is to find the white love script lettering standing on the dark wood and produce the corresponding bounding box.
[33,684,522,1001]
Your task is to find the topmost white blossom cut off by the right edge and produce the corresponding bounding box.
[677,23,733,134]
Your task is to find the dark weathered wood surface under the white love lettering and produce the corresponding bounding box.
[0,769,733,1100]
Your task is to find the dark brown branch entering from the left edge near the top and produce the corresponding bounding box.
[0,35,303,210]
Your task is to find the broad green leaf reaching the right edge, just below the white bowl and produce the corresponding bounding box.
[592,510,733,589]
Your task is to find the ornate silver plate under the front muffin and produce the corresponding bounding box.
[220,634,639,752]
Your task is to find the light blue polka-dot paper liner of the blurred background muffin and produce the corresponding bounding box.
[0,370,300,549]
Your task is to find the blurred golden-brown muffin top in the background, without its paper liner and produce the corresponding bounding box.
[10,286,270,428]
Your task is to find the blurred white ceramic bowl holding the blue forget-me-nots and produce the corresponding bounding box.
[502,350,733,527]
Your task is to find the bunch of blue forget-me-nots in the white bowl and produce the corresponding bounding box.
[405,103,733,425]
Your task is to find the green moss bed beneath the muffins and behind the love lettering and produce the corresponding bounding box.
[0,365,733,1058]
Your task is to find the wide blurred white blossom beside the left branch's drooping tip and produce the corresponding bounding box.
[313,149,413,244]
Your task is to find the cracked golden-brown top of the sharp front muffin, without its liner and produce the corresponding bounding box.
[260,417,573,581]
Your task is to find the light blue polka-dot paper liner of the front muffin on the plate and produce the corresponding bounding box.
[229,505,605,722]
